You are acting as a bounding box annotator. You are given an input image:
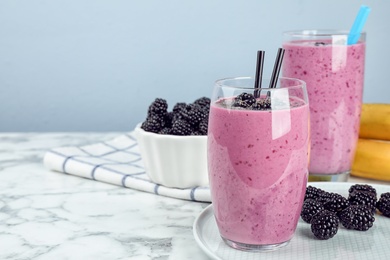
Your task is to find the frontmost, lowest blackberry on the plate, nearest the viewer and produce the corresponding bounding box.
[311,210,339,240]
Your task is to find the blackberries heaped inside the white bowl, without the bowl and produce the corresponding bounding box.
[141,97,210,136]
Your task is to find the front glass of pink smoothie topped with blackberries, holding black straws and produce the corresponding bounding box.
[208,77,310,251]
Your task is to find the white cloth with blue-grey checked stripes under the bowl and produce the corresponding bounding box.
[43,132,211,202]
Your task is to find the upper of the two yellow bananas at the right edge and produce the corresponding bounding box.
[359,103,390,140]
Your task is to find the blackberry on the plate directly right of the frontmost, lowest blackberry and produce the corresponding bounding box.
[339,205,375,231]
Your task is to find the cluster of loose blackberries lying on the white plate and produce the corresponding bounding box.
[301,184,390,239]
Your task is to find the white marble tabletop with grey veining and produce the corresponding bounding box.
[0,133,386,260]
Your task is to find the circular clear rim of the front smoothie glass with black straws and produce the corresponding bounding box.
[214,76,306,91]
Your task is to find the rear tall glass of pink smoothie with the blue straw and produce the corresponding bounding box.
[282,30,366,181]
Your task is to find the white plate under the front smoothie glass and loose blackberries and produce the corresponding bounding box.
[193,182,390,260]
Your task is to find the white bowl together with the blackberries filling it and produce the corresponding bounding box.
[134,97,210,188]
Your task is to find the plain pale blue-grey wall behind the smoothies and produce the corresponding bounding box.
[0,0,390,132]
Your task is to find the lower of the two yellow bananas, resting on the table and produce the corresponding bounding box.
[351,138,390,181]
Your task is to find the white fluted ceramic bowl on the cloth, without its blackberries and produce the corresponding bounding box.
[134,124,209,189]
